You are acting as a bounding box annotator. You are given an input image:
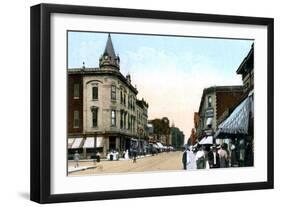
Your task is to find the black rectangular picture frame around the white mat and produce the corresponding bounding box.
[30,4,274,203]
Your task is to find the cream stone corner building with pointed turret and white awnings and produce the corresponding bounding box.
[68,34,148,158]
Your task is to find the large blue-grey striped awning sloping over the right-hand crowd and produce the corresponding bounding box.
[215,96,253,138]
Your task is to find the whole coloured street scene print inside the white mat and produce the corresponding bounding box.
[66,31,254,176]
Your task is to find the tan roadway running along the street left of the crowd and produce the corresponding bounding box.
[68,151,182,176]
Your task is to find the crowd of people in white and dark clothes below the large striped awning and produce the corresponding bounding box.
[182,144,253,170]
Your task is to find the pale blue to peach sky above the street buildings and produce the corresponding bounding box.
[68,32,253,141]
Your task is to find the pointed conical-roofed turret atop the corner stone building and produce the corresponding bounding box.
[99,34,120,70]
